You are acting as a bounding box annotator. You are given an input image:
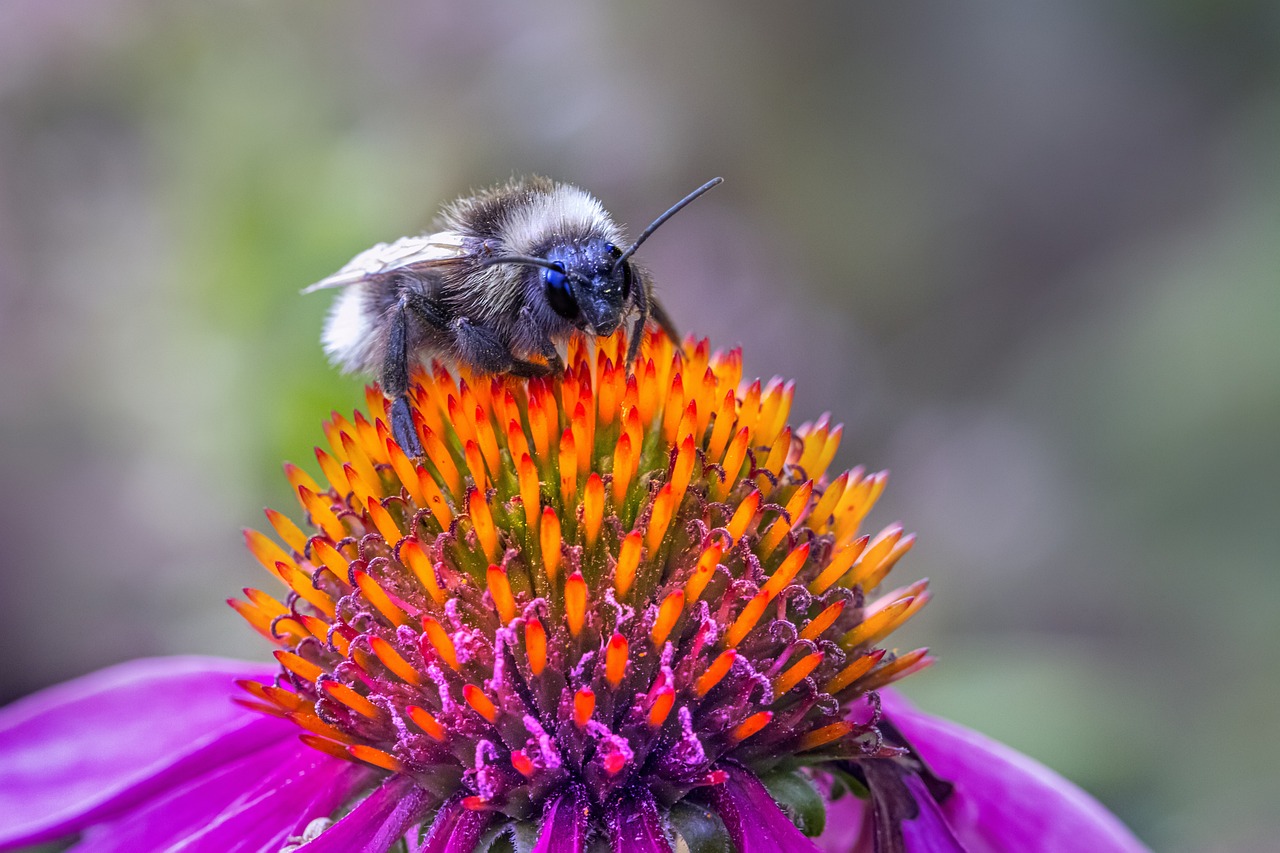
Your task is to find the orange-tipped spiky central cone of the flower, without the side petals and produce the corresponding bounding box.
[232,334,941,853]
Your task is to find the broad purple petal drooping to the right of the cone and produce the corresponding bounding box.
[882,692,1147,853]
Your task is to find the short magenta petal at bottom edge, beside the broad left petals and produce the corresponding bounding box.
[298,776,435,853]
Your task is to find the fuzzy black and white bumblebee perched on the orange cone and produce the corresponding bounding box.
[302,171,723,456]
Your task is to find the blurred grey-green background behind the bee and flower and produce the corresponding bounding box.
[0,0,1280,852]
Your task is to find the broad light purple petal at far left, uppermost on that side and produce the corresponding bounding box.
[0,657,297,849]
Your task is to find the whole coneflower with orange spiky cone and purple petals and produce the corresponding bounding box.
[0,326,1144,853]
